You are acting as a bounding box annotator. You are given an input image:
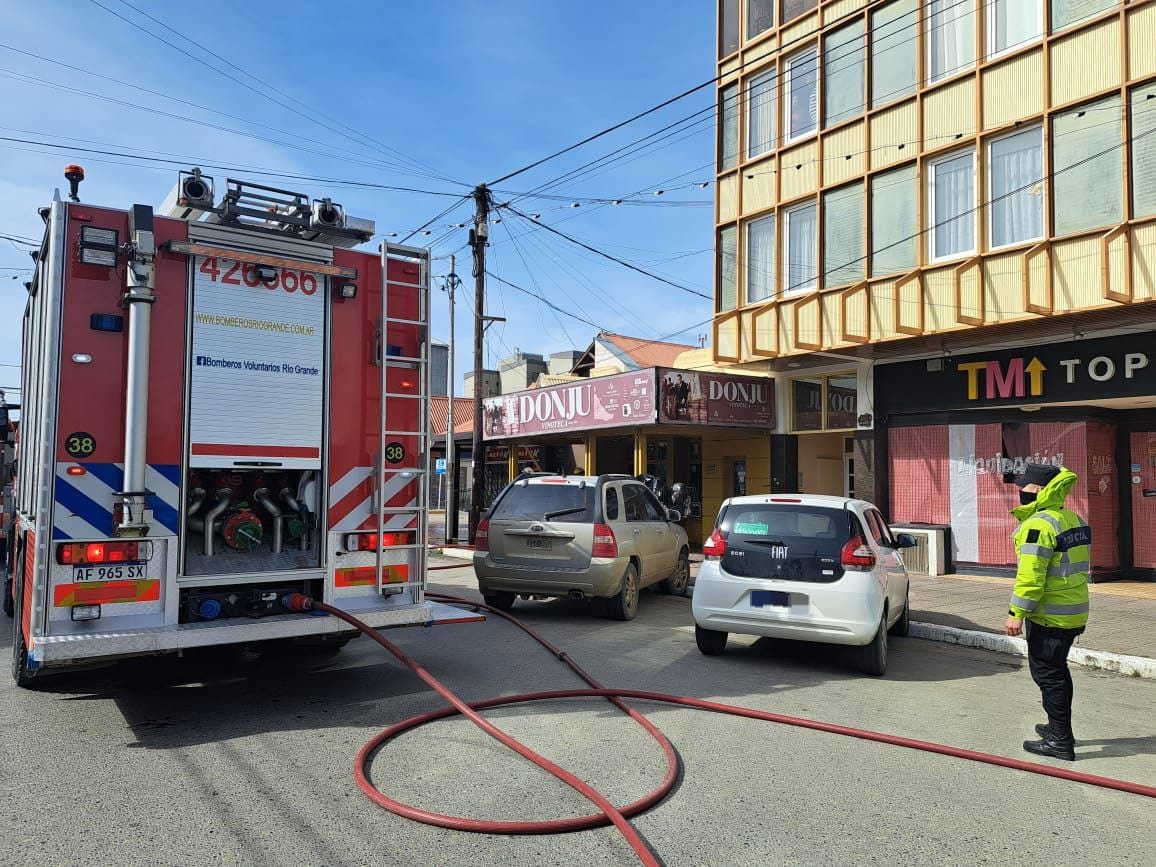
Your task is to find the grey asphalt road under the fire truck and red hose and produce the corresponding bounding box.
[0,569,1156,867]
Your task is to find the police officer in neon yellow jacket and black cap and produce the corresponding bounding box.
[1005,464,1091,762]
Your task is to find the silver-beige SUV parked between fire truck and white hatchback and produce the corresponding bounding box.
[474,474,690,620]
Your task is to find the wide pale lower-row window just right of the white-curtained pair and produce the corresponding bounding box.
[1052,96,1124,235]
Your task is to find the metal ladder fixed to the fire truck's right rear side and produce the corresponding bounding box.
[373,242,430,602]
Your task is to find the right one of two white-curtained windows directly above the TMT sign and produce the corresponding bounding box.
[987,126,1044,247]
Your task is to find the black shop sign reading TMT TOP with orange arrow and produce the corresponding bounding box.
[875,333,1156,414]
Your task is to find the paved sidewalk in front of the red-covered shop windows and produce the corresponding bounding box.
[911,575,1156,659]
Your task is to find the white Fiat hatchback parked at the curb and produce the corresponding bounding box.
[691,494,916,675]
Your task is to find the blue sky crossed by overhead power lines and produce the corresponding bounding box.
[0,0,714,399]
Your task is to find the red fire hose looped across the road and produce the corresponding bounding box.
[286,593,1156,867]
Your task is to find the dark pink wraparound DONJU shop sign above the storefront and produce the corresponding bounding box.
[482,368,775,439]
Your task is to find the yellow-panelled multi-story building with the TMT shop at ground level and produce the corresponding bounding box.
[713,0,1156,584]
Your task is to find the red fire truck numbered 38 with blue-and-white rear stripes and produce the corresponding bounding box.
[9,166,476,686]
